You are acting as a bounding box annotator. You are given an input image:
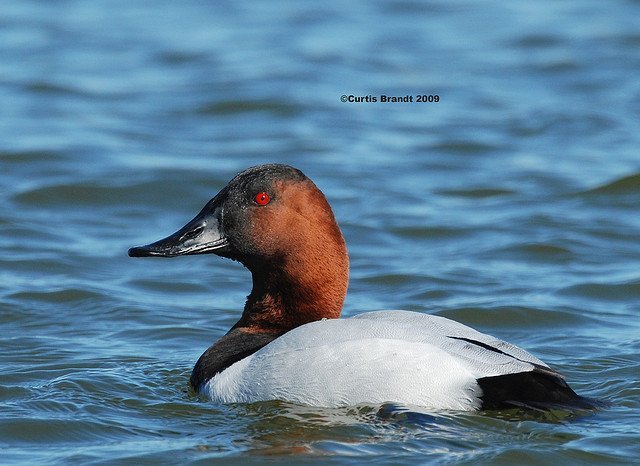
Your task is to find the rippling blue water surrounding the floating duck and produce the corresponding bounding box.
[0,0,640,464]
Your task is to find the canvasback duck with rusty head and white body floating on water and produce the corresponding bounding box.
[129,164,593,411]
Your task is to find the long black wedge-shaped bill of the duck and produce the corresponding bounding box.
[129,204,230,257]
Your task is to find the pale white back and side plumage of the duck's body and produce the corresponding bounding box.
[203,311,548,410]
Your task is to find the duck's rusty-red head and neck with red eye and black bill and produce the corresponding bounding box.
[129,164,349,327]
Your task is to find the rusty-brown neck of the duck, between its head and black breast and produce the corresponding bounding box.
[234,240,349,333]
